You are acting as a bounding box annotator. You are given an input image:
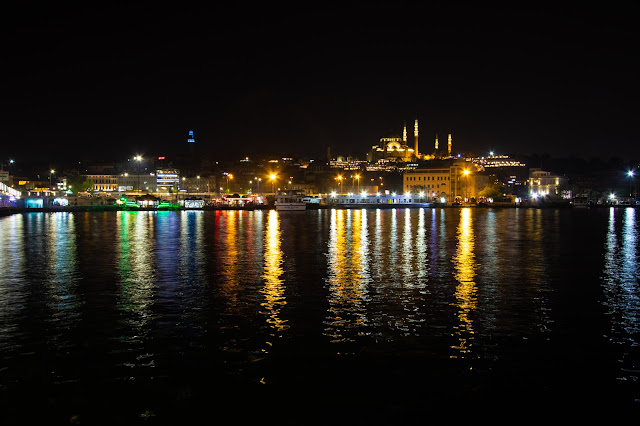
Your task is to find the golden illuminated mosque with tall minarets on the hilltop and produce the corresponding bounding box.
[367,119,452,163]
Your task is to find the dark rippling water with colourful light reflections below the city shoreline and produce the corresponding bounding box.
[0,208,640,424]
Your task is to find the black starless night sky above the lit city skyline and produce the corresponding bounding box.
[0,2,640,160]
